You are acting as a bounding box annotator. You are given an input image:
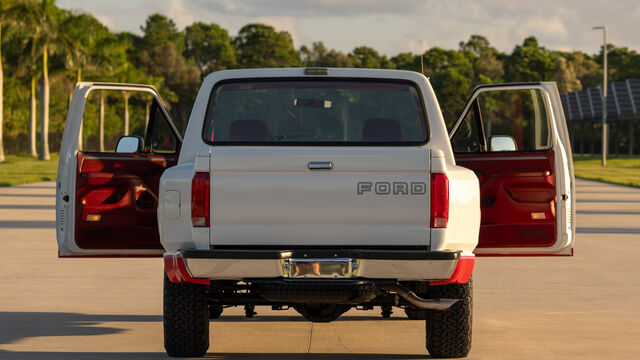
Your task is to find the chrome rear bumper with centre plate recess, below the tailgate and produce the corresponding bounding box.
[165,249,473,283]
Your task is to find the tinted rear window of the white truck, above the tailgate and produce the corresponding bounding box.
[203,80,428,145]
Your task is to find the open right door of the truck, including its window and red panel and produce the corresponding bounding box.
[450,82,575,256]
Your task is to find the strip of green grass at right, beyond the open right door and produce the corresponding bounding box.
[573,156,640,187]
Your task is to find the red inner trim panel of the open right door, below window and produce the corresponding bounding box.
[456,151,556,248]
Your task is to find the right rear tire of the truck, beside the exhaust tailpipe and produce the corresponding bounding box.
[425,279,473,358]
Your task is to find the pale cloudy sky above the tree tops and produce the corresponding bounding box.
[56,0,640,56]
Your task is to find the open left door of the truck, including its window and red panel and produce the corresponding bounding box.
[56,82,182,257]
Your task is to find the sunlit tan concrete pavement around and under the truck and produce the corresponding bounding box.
[0,181,640,360]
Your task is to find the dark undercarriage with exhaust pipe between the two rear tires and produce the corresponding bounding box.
[202,278,458,322]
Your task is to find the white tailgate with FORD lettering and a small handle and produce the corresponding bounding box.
[210,146,430,247]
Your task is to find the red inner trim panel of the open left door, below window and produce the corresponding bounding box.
[75,152,177,249]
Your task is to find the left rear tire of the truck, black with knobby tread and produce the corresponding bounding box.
[163,274,209,357]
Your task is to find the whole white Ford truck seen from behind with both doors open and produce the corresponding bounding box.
[56,68,575,357]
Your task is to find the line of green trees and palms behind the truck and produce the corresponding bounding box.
[0,0,640,162]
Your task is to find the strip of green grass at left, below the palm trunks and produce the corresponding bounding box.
[0,154,58,186]
